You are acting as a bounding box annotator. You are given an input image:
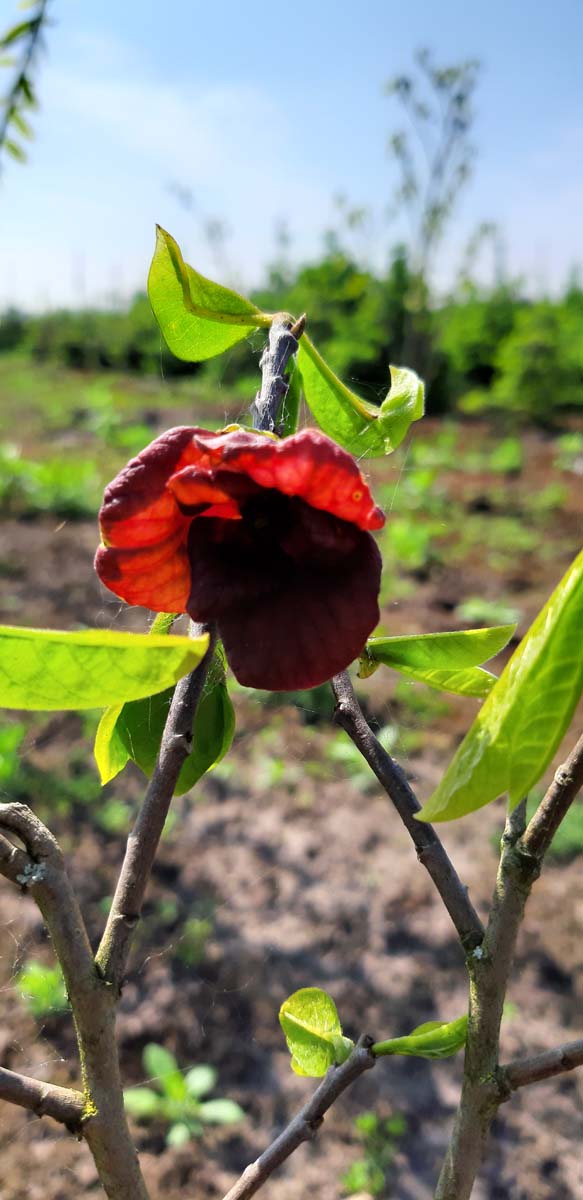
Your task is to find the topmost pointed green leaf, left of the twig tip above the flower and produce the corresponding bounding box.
[148,226,271,362]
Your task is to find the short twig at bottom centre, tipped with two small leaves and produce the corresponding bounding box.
[224,1038,377,1200]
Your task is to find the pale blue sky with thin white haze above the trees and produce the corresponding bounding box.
[0,0,583,308]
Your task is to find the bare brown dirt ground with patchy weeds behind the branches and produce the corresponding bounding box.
[0,422,583,1200]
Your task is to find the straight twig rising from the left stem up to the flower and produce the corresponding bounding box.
[96,625,216,990]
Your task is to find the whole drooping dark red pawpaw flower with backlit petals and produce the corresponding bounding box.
[96,427,384,691]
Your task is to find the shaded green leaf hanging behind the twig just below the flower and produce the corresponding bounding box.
[94,638,235,796]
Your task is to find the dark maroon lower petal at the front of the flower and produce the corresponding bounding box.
[218,534,381,691]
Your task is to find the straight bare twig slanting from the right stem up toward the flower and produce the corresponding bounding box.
[332,671,483,953]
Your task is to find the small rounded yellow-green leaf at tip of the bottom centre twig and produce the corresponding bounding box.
[280,988,354,1079]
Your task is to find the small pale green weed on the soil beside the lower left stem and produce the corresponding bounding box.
[124,1043,245,1146]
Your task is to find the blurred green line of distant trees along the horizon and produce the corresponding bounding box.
[0,235,583,424]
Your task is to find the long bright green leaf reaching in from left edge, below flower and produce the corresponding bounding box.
[0,625,209,712]
